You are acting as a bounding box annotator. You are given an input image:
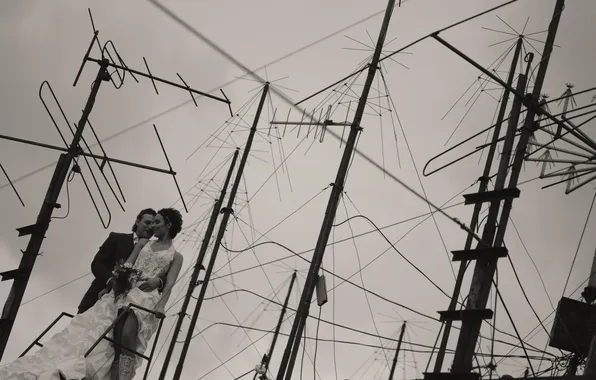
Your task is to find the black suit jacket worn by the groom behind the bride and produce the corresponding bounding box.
[79,232,134,313]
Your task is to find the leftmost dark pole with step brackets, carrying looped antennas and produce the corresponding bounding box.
[0,59,110,359]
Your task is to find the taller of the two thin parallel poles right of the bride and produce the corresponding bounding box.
[169,82,269,380]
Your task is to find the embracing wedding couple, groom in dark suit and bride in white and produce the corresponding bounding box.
[0,208,182,380]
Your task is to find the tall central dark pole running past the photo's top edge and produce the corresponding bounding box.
[277,0,395,380]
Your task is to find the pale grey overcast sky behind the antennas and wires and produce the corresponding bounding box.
[0,0,596,379]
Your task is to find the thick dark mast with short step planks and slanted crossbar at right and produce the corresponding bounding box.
[425,0,567,380]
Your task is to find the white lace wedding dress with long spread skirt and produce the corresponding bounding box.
[0,242,175,380]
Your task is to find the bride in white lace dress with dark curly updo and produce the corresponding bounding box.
[0,208,182,380]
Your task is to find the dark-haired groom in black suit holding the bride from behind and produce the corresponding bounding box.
[78,208,163,314]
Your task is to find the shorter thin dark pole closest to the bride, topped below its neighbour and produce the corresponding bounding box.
[159,149,239,380]
